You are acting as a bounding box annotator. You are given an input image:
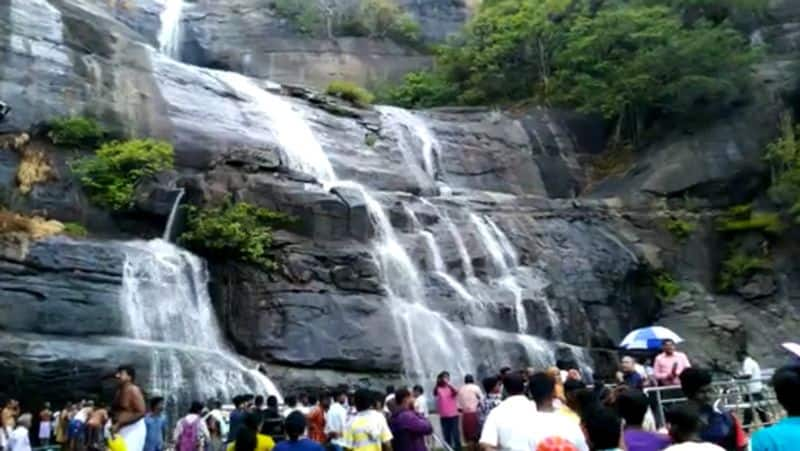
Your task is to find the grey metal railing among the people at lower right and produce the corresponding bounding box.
[644,377,786,430]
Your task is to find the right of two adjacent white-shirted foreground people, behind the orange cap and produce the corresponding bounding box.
[528,372,589,451]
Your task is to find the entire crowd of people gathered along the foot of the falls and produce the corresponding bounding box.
[0,341,800,451]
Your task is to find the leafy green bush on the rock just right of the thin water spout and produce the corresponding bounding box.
[180,202,289,269]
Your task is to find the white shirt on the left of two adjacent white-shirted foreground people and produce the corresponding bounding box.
[480,395,537,451]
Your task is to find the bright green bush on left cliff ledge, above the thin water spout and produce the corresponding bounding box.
[72,139,173,210]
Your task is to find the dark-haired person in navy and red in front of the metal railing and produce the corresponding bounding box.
[680,368,747,451]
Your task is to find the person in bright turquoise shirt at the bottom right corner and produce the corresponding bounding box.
[752,365,800,451]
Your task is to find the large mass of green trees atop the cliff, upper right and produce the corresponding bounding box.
[383,0,758,142]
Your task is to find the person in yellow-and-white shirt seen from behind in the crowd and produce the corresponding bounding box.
[342,389,393,451]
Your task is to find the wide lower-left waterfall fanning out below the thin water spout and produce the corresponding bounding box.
[120,240,280,416]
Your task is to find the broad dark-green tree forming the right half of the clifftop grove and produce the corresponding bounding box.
[549,6,755,139]
